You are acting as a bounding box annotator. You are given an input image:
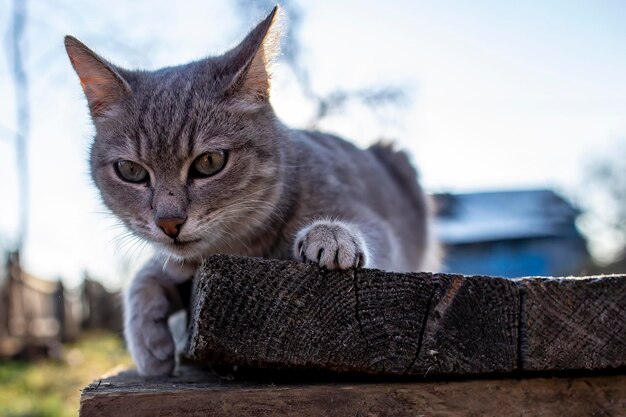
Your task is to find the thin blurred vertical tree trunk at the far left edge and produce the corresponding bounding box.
[7,0,30,251]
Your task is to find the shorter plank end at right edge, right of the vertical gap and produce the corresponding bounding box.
[520,275,626,370]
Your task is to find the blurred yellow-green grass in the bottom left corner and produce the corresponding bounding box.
[0,333,131,417]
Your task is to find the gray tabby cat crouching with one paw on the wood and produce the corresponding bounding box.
[65,8,434,375]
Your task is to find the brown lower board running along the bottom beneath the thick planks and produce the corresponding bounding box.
[80,368,626,417]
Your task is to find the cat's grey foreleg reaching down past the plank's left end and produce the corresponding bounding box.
[124,259,195,376]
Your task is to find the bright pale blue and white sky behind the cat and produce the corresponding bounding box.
[0,0,626,287]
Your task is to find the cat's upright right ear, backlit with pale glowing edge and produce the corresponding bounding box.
[224,6,281,108]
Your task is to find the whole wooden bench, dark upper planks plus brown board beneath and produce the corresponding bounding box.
[81,256,626,416]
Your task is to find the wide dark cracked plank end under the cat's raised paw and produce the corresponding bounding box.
[189,256,519,375]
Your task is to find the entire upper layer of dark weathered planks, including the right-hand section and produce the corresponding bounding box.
[188,255,626,375]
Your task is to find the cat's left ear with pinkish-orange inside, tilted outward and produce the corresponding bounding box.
[65,36,131,119]
